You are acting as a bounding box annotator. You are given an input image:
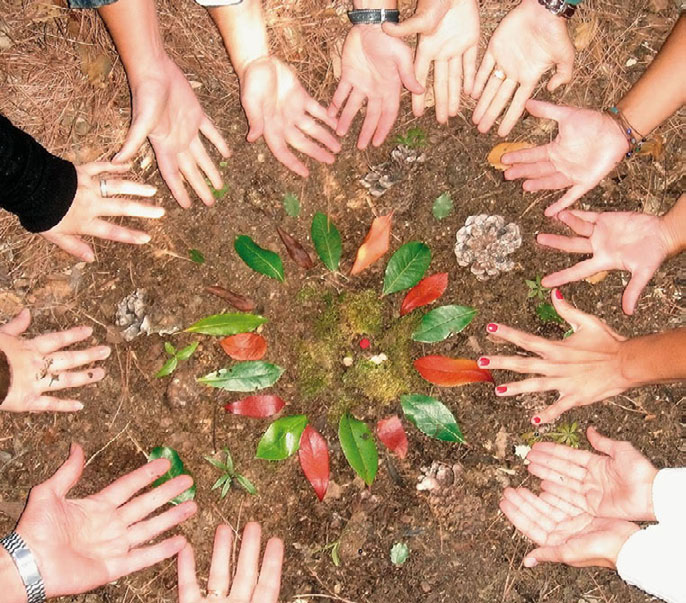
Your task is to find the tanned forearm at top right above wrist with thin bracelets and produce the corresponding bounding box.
[617,15,686,136]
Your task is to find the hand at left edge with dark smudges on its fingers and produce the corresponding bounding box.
[0,310,111,412]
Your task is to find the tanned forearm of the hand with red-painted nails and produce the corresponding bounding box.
[619,328,686,387]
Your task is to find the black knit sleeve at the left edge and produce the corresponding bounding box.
[0,115,78,232]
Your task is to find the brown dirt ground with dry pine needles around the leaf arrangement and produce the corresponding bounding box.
[0,0,686,603]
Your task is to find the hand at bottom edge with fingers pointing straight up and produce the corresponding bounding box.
[178,522,283,603]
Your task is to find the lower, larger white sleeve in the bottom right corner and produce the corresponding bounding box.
[617,524,686,603]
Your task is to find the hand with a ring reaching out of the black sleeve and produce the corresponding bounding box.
[41,163,164,262]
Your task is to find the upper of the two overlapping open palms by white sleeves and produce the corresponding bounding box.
[526,427,657,521]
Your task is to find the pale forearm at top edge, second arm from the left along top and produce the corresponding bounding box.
[208,0,269,80]
